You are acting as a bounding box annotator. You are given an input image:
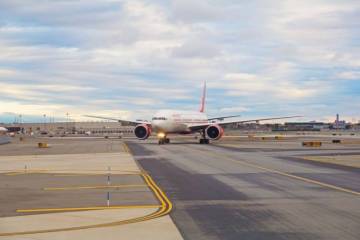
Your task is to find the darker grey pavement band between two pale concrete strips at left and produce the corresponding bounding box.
[0,172,158,217]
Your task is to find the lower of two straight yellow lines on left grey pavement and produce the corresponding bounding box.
[16,205,161,213]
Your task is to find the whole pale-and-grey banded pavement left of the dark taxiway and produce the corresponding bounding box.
[0,139,182,240]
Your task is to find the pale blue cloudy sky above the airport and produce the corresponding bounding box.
[0,0,360,122]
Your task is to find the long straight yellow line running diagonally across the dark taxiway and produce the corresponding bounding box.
[198,145,360,196]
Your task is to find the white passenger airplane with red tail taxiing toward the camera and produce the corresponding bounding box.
[85,82,301,144]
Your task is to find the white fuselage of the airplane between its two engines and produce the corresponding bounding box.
[151,110,208,134]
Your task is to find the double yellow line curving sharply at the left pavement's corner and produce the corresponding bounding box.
[0,172,172,236]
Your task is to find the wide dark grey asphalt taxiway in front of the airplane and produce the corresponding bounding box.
[127,140,360,240]
